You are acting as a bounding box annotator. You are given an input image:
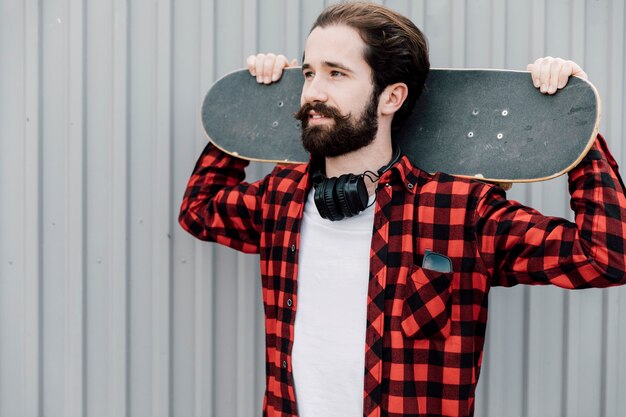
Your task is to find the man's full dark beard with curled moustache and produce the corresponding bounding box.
[294,94,378,157]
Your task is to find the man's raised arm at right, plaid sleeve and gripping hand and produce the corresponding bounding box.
[476,57,626,288]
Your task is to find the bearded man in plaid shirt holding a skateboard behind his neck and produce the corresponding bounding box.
[180,2,626,417]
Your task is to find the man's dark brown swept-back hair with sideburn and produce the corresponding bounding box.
[311,1,430,129]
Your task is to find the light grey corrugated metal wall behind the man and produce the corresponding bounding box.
[0,0,626,417]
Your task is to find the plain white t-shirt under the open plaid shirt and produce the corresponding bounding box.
[292,191,374,417]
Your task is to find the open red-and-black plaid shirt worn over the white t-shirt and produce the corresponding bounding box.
[180,136,626,417]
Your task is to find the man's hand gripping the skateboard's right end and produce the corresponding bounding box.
[526,56,587,94]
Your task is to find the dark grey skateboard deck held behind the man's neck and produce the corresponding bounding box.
[202,68,601,183]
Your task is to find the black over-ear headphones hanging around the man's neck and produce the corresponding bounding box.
[313,146,401,221]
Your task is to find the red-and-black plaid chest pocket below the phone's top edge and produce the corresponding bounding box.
[401,266,453,339]
